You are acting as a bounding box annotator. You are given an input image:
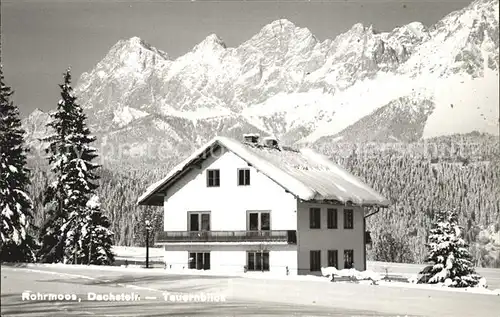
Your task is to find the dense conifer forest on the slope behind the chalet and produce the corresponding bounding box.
[24,134,500,267]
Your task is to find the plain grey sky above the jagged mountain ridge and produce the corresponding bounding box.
[0,0,470,115]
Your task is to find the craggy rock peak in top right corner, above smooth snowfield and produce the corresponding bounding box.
[401,0,499,77]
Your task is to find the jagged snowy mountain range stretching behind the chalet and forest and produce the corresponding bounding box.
[24,0,499,167]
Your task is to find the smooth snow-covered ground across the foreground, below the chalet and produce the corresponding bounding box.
[1,264,500,317]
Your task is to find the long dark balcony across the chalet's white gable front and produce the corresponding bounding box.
[155,230,297,244]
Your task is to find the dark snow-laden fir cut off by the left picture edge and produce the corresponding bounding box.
[0,66,35,262]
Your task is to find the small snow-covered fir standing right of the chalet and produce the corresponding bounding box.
[420,211,481,287]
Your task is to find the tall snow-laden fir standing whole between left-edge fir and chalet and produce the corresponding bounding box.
[40,69,113,264]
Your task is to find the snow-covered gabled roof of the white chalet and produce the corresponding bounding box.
[137,137,389,207]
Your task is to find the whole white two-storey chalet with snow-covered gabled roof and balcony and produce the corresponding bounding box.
[138,134,389,275]
